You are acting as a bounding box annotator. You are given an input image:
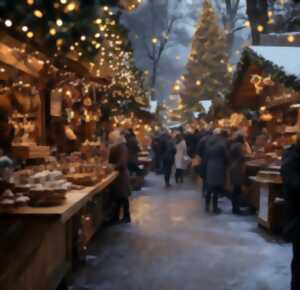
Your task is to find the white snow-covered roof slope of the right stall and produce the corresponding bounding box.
[250,46,300,78]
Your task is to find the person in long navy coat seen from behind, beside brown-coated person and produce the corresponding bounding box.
[205,129,228,214]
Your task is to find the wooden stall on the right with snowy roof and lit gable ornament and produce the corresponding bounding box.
[229,46,300,230]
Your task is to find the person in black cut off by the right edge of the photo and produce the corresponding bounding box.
[281,133,300,290]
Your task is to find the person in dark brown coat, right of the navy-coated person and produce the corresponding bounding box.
[229,135,245,214]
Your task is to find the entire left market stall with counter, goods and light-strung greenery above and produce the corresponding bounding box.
[0,1,150,290]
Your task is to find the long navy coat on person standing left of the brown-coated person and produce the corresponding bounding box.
[204,135,227,187]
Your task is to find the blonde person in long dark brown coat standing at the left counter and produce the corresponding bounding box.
[109,130,131,223]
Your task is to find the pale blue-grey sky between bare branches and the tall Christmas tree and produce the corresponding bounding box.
[122,0,248,99]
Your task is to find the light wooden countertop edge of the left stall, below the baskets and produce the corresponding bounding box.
[3,171,118,222]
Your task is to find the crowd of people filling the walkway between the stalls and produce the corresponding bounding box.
[152,128,248,214]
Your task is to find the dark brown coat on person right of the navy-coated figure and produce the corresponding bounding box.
[229,142,246,186]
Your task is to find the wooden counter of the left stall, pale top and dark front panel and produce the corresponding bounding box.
[0,172,118,290]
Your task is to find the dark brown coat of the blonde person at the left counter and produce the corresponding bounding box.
[109,143,131,198]
